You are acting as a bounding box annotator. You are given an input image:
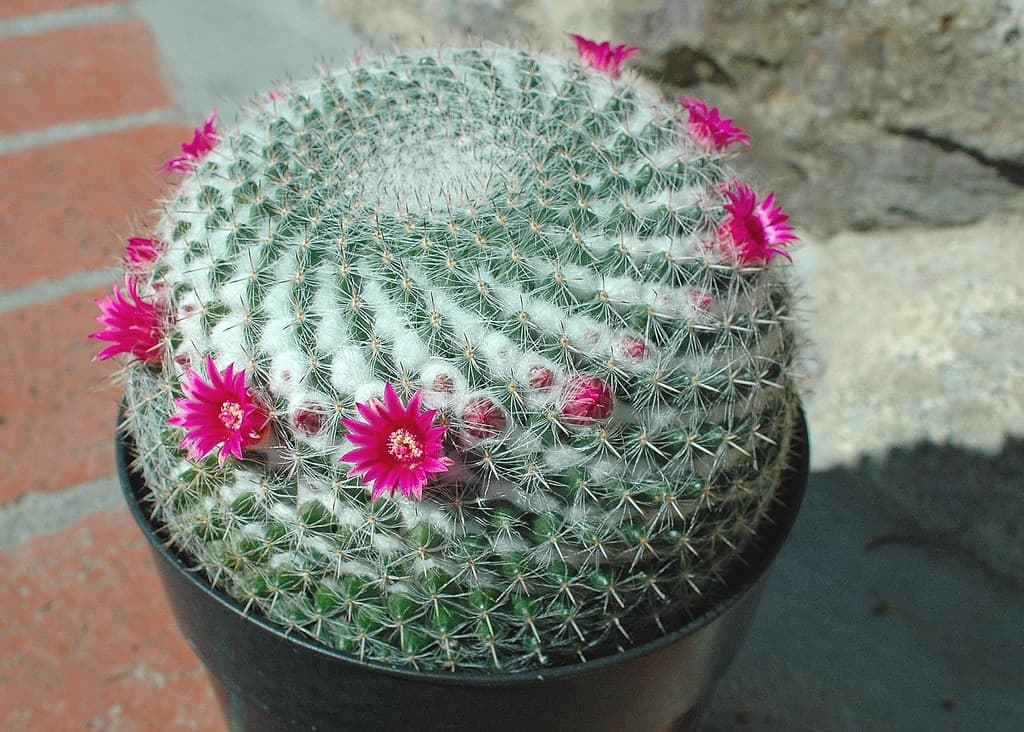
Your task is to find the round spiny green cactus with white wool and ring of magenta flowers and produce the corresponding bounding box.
[94,39,799,672]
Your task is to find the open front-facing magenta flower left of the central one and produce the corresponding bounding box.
[167,356,270,465]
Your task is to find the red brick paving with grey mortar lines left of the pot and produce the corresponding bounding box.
[0,0,223,732]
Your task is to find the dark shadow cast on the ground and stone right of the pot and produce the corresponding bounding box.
[706,438,1024,732]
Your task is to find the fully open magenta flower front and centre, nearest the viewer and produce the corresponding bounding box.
[341,383,452,501]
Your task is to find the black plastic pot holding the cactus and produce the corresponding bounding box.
[117,411,810,732]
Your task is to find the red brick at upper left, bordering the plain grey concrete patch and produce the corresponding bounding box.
[0,20,171,134]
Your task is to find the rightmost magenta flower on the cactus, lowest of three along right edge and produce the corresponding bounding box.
[718,183,797,264]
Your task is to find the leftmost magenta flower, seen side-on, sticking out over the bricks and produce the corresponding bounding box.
[89,277,167,363]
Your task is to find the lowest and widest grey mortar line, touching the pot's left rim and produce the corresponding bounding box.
[0,475,124,549]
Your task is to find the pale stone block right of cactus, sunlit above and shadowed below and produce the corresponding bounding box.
[794,215,1024,580]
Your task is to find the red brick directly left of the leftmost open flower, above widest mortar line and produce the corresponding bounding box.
[0,283,119,505]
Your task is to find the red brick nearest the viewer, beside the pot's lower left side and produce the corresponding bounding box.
[0,509,224,732]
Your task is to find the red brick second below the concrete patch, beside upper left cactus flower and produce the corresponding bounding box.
[0,124,191,288]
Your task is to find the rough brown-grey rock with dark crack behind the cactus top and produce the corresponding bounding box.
[324,0,1024,232]
